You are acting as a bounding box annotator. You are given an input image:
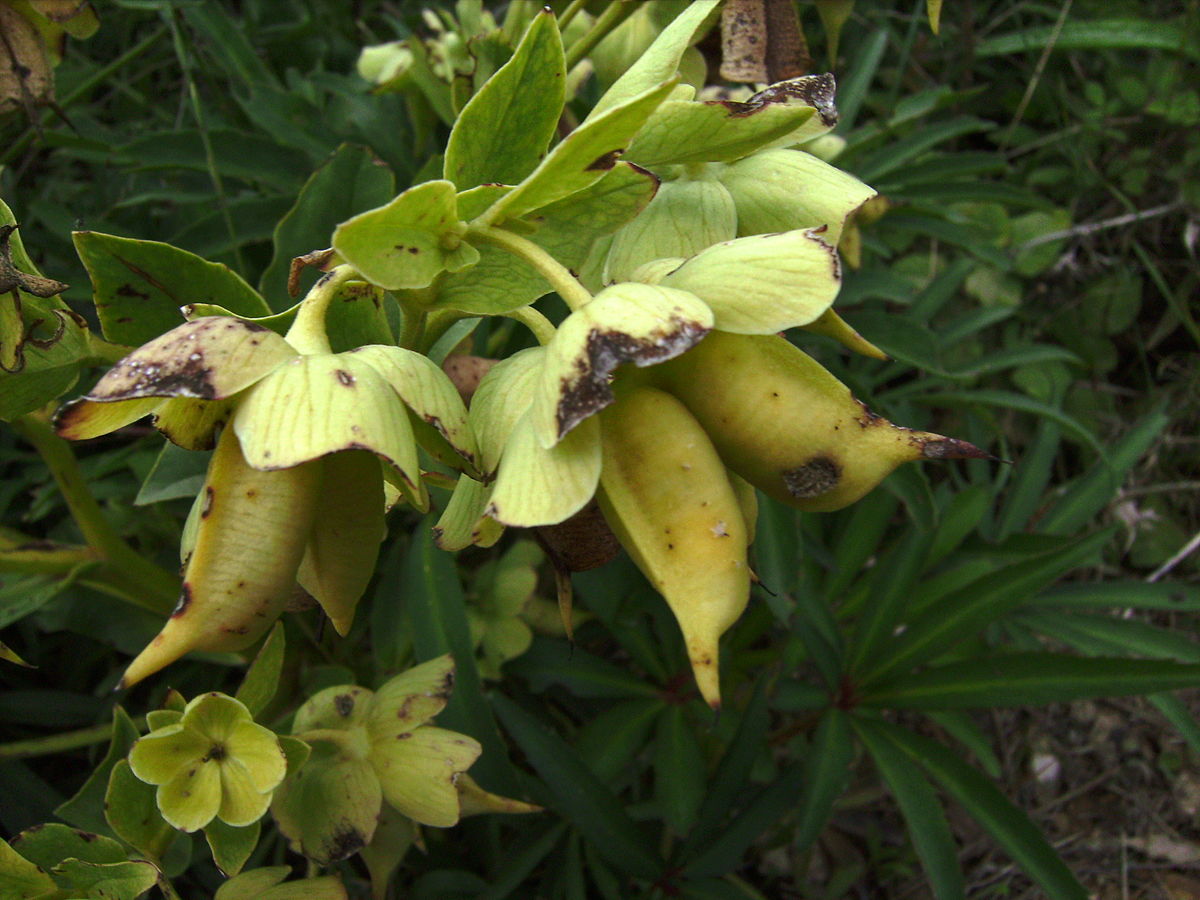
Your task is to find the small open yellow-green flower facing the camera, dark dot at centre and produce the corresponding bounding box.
[130,692,287,832]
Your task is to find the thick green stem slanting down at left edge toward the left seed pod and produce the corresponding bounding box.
[11,414,179,613]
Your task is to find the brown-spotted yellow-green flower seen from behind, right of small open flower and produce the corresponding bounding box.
[271,656,481,863]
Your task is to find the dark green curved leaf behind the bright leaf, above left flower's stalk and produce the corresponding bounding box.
[258,144,396,310]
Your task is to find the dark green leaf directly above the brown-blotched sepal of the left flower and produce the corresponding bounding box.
[72,232,271,346]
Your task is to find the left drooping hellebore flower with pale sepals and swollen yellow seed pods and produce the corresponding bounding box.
[56,266,475,686]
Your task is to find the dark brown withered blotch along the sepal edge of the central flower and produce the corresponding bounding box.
[556,318,710,438]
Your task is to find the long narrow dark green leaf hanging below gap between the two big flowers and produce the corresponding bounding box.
[404,521,520,796]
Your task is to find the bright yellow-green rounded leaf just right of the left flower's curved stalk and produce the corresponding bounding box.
[334,181,479,290]
